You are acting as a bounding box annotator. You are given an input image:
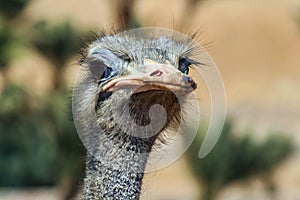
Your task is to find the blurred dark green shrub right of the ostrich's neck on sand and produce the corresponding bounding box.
[187,121,293,200]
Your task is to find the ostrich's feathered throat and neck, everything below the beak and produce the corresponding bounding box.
[83,81,180,200]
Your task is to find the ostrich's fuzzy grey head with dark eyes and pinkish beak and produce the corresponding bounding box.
[84,35,197,137]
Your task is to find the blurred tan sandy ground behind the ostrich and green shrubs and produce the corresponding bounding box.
[0,0,300,200]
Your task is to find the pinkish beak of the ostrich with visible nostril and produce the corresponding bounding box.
[102,59,197,93]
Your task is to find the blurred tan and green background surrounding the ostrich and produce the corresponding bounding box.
[0,0,300,200]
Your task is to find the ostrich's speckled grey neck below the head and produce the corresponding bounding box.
[83,127,155,200]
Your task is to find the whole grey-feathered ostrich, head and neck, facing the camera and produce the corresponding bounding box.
[73,28,199,200]
